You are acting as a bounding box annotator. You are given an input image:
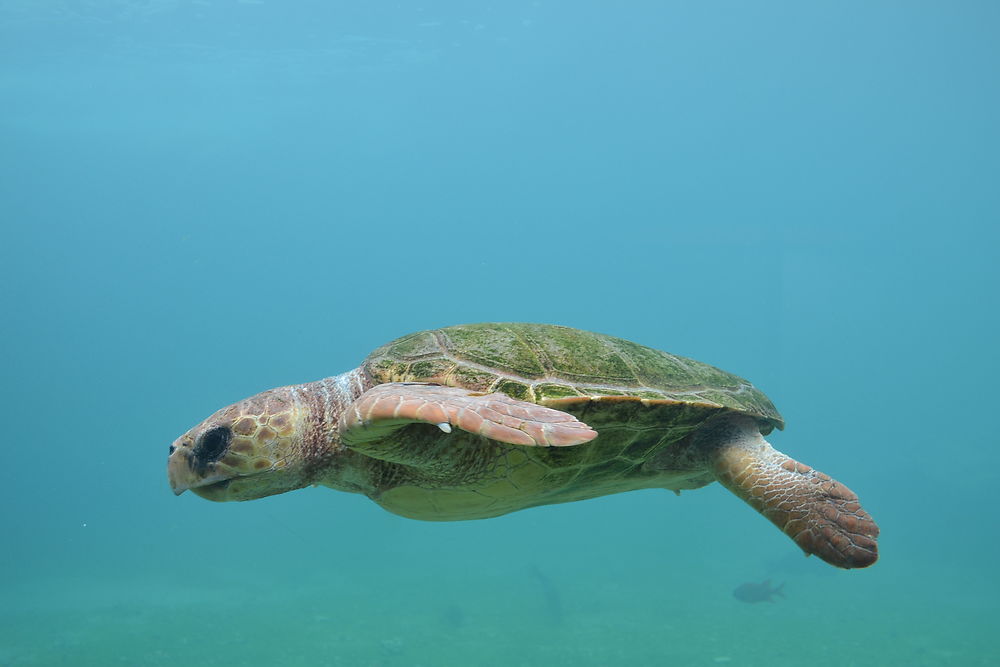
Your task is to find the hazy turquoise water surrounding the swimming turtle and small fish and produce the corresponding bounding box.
[0,0,1000,667]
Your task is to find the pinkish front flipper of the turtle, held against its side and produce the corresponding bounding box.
[338,382,597,447]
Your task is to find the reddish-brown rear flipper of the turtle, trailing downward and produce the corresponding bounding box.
[709,417,879,568]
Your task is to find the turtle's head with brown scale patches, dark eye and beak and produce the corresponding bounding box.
[167,387,316,501]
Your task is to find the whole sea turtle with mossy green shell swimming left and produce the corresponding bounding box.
[167,323,878,568]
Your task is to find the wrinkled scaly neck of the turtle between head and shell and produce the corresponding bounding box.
[293,368,373,488]
